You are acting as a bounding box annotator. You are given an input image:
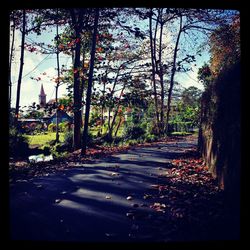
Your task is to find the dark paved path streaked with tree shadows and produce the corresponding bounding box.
[10,138,231,242]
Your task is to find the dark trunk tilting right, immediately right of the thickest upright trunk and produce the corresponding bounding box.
[81,8,99,155]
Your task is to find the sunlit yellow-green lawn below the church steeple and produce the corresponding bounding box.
[25,132,65,146]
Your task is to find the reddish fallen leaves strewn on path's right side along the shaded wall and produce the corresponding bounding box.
[123,157,227,241]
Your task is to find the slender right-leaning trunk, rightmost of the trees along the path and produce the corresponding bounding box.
[165,16,182,134]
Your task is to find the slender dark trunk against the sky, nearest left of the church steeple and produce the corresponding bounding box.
[14,10,26,128]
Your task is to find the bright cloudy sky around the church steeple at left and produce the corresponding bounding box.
[9,28,71,107]
